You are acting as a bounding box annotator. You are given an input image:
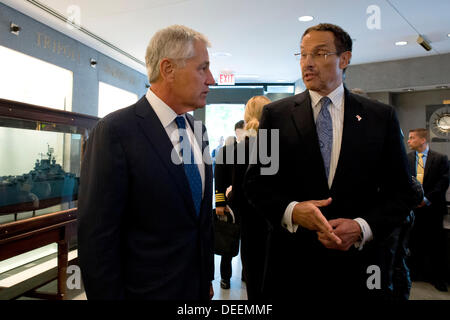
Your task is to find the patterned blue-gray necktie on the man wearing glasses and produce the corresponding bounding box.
[316,97,333,179]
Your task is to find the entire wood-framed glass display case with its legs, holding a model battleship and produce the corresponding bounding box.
[0,99,99,299]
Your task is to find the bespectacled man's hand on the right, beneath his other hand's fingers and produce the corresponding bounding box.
[317,219,361,251]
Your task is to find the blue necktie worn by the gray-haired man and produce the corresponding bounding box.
[175,116,202,215]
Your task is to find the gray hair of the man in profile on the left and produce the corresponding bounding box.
[145,25,211,83]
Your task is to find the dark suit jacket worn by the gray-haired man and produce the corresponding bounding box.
[78,97,214,300]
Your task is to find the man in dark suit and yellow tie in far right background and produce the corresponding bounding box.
[408,128,449,292]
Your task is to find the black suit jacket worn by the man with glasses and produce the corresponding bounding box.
[245,89,411,297]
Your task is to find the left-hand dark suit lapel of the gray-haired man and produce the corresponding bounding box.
[136,96,197,217]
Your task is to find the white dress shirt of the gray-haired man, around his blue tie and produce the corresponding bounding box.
[145,88,205,197]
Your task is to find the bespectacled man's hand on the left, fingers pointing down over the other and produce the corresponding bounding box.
[292,198,342,245]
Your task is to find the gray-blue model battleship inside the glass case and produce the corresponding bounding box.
[0,146,79,214]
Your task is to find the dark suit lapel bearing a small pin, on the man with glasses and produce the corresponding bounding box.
[331,88,366,189]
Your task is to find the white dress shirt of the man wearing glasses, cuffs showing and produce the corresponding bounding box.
[281,84,373,249]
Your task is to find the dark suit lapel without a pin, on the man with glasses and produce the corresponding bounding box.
[292,90,328,190]
